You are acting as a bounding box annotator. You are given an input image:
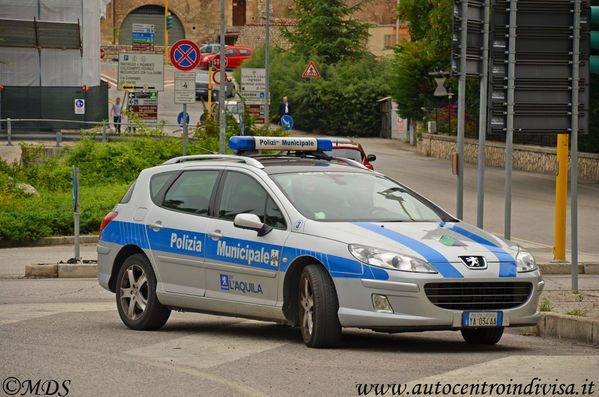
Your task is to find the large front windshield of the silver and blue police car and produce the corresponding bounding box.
[272,172,453,222]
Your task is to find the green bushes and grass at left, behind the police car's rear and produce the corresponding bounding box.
[0,118,282,241]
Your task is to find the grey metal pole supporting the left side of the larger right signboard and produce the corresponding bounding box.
[503,0,518,240]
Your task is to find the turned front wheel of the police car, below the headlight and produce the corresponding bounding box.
[298,265,341,347]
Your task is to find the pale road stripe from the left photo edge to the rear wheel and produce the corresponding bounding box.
[0,301,116,325]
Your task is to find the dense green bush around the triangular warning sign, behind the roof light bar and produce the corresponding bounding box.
[235,47,390,136]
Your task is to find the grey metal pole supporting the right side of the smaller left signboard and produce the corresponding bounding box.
[476,0,490,228]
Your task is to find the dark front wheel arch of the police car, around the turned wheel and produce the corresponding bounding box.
[283,255,339,326]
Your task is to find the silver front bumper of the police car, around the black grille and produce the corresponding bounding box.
[335,271,544,332]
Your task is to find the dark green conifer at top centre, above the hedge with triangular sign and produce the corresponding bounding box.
[282,0,370,64]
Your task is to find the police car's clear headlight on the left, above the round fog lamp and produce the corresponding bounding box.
[348,244,437,273]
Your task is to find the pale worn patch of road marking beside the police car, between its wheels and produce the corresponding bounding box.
[127,320,285,369]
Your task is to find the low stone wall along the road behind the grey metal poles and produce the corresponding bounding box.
[417,134,599,182]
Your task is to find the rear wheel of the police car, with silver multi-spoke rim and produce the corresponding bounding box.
[116,254,171,330]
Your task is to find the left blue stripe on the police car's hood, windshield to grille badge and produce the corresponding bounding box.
[353,222,464,278]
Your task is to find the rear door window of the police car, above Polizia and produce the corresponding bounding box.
[162,170,219,215]
